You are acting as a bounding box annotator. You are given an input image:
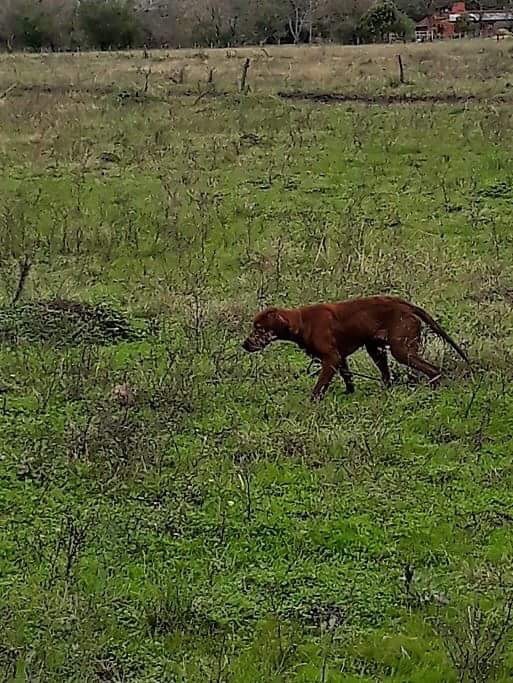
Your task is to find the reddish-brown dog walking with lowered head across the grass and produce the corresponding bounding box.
[243,296,470,399]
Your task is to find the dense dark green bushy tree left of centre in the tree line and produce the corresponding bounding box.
[77,0,140,50]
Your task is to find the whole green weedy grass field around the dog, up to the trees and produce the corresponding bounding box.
[0,41,513,683]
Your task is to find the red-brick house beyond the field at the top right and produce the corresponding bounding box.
[415,2,513,42]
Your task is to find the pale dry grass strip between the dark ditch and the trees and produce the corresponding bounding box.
[0,39,513,100]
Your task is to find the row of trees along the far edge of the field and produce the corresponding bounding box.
[0,0,468,50]
